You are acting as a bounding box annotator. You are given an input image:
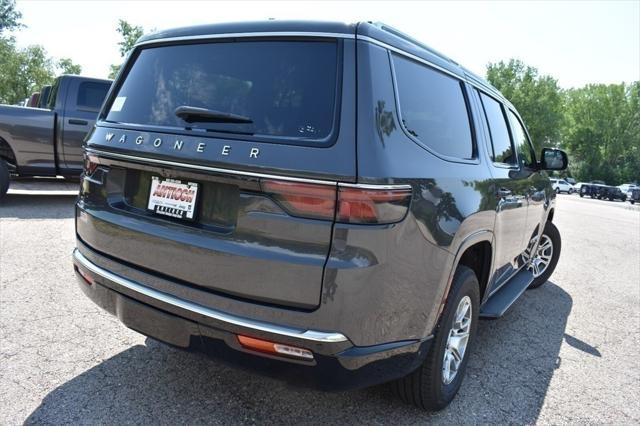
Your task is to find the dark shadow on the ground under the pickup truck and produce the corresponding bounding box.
[0,194,78,219]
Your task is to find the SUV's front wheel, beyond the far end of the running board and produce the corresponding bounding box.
[523,222,562,288]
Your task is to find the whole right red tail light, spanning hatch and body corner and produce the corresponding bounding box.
[262,179,411,224]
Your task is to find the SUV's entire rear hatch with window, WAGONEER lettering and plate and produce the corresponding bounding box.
[77,35,355,309]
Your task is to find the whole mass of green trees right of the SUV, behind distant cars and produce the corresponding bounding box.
[487,59,640,185]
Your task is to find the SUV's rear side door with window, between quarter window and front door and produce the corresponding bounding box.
[478,92,529,290]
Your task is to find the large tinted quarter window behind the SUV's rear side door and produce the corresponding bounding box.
[393,55,473,159]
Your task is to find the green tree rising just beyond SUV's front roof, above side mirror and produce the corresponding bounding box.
[487,59,563,152]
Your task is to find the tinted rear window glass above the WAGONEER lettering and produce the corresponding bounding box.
[106,40,338,140]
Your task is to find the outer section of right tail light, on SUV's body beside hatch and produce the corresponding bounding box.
[336,186,411,224]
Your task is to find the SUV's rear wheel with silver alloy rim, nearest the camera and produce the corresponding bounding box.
[394,266,480,410]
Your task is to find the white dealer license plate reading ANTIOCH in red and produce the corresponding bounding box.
[147,176,198,220]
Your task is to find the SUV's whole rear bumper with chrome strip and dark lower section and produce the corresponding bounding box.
[73,250,431,390]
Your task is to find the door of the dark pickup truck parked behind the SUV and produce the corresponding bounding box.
[60,78,110,173]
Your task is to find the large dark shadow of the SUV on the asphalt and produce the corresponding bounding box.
[26,282,576,424]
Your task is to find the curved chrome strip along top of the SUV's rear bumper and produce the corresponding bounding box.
[73,249,348,343]
